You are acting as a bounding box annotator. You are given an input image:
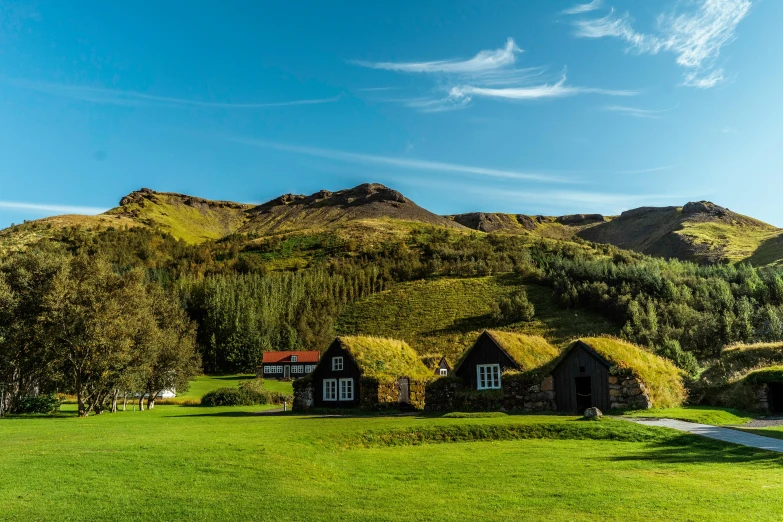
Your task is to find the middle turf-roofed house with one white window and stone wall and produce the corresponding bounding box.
[427,330,559,411]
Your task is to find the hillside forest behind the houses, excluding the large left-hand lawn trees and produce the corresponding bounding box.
[10,219,783,382]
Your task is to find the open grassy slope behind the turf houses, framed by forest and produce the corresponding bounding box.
[337,276,618,361]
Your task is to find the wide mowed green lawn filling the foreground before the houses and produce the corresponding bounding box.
[0,406,783,522]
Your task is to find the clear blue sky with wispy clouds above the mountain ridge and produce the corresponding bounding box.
[0,0,783,226]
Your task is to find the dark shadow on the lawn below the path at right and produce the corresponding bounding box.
[610,435,783,466]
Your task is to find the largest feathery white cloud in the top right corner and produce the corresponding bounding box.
[574,0,751,89]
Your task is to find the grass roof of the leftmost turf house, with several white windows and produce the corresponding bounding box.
[338,336,433,381]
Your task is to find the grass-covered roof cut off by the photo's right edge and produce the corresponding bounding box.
[702,343,783,385]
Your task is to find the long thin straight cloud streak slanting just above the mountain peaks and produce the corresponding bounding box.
[222,136,570,183]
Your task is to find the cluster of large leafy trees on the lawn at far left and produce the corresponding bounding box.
[0,243,200,416]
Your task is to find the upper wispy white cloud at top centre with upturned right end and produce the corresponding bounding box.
[353,38,522,74]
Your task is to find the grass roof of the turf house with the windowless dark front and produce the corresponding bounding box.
[581,337,686,408]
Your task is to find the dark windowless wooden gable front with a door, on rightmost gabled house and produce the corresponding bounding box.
[552,341,612,413]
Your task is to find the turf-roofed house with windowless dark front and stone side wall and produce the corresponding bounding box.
[551,337,685,413]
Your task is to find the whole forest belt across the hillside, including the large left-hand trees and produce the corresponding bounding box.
[0,223,783,414]
